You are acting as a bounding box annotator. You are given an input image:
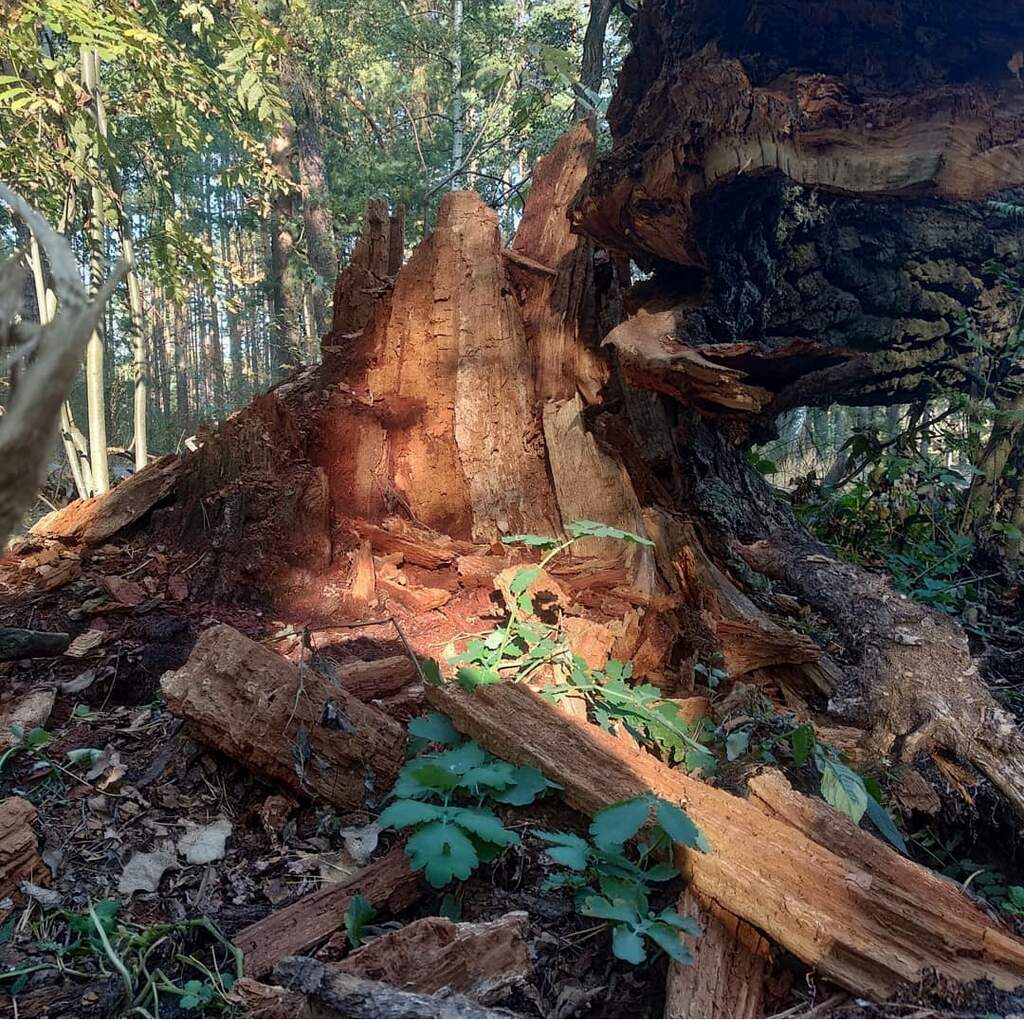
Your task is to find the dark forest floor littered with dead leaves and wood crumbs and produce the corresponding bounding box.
[0,522,1022,1017]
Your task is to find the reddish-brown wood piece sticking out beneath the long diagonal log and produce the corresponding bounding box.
[665,889,771,1020]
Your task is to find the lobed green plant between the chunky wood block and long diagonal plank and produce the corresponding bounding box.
[378,713,559,889]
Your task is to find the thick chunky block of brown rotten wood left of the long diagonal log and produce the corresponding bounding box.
[161,625,406,808]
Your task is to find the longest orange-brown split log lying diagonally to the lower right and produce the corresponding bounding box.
[427,683,1024,1001]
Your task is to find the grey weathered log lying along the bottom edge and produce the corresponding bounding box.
[273,957,516,1018]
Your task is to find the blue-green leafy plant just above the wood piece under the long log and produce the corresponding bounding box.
[535,795,710,965]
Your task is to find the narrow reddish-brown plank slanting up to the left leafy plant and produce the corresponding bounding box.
[234,846,420,977]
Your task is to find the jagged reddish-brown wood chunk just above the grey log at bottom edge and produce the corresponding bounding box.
[336,911,534,1006]
